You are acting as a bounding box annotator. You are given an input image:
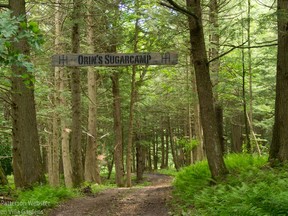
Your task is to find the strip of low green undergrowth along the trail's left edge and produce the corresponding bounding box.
[0,176,116,216]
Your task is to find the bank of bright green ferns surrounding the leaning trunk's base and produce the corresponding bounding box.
[174,154,288,216]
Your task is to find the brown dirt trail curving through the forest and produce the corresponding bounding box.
[48,174,172,216]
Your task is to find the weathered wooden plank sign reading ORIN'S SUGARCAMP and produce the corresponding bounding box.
[52,52,178,67]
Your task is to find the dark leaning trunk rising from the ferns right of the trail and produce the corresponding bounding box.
[186,0,228,179]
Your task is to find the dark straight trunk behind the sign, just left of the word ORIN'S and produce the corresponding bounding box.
[71,0,84,187]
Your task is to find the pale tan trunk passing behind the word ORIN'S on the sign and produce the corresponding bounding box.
[84,0,101,184]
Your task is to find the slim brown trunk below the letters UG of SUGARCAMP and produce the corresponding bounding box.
[111,72,124,187]
